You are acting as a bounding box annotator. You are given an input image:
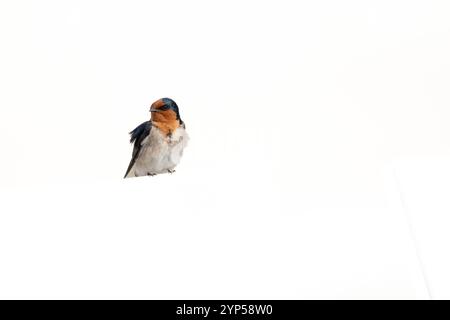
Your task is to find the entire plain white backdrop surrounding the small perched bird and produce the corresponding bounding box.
[0,0,450,299]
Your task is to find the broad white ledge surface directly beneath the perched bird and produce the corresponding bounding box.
[0,170,428,299]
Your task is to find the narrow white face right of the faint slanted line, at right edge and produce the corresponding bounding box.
[395,157,450,300]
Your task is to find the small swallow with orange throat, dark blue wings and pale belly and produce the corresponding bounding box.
[124,98,189,178]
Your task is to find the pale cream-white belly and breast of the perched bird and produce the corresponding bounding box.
[128,127,189,177]
